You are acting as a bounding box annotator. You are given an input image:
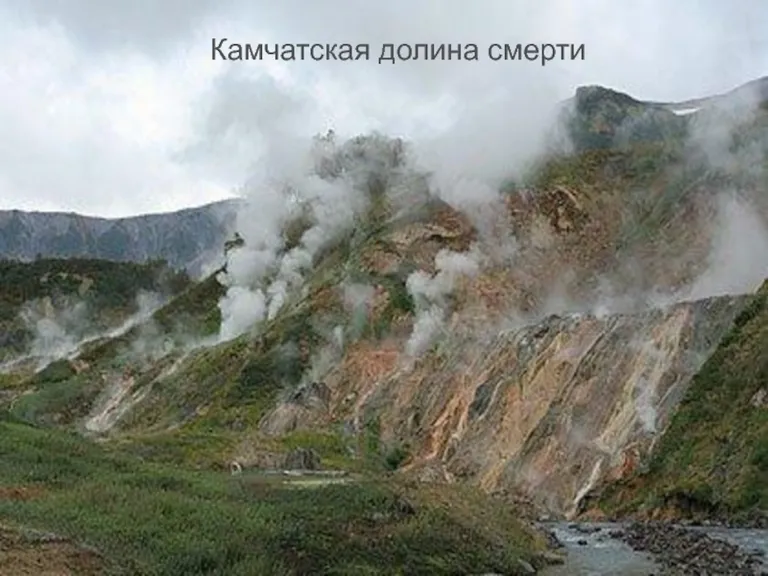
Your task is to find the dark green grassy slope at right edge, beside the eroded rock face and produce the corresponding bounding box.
[599,284,768,519]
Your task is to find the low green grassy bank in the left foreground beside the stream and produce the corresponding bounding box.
[0,421,542,576]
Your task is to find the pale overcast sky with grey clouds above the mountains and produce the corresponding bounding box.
[0,0,768,216]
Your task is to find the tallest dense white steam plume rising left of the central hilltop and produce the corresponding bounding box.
[219,133,403,340]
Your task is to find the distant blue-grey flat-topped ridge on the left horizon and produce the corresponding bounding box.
[0,200,239,275]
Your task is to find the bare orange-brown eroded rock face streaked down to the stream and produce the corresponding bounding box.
[284,297,747,515]
